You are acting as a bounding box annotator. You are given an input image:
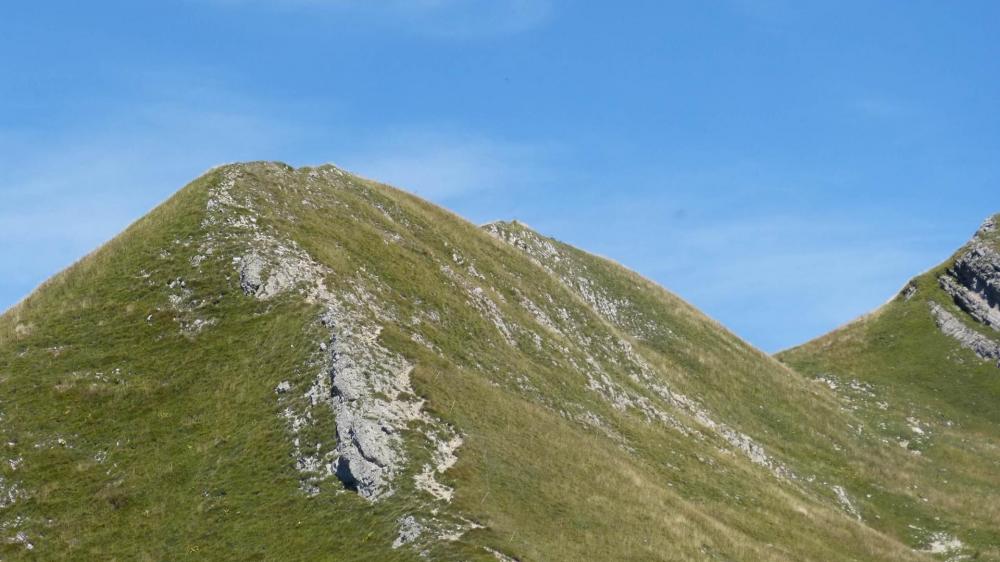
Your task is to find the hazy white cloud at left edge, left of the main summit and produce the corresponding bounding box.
[0,82,290,310]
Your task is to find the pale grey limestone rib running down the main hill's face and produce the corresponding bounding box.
[210,169,461,501]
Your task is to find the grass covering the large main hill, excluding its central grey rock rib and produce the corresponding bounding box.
[0,164,952,560]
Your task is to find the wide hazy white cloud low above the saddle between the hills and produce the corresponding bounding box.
[523,158,966,351]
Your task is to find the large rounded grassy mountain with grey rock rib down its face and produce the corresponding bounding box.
[0,163,1000,561]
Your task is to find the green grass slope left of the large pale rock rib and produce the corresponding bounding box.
[0,173,418,560]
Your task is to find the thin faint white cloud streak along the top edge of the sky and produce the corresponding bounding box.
[196,0,554,39]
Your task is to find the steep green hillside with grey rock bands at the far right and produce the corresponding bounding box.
[779,212,1000,560]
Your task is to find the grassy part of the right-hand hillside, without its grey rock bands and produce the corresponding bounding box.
[779,218,1000,560]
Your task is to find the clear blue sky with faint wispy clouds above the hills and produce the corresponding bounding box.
[0,0,1000,351]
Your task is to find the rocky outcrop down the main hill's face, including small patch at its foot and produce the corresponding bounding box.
[199,164,480,552]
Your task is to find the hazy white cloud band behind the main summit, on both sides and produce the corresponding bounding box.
[0,70,554,309]
